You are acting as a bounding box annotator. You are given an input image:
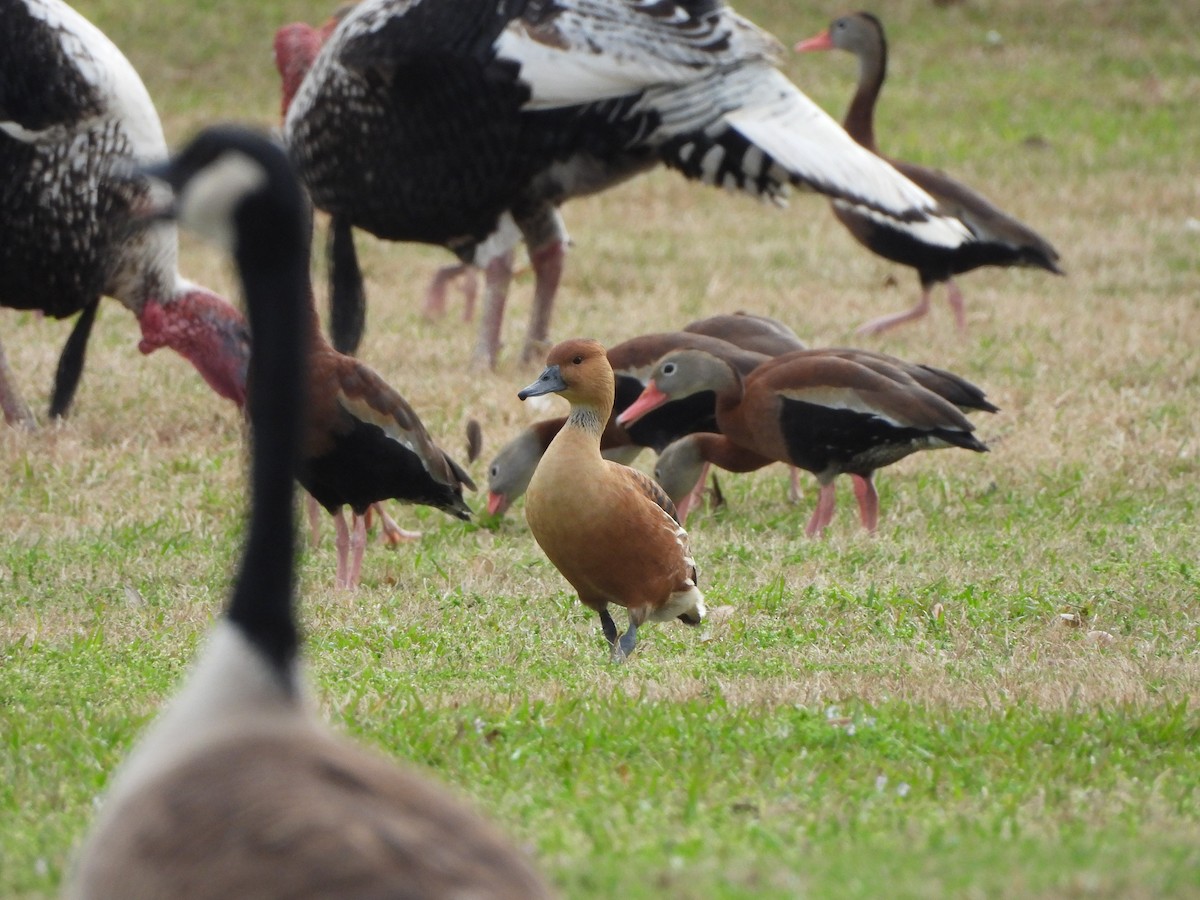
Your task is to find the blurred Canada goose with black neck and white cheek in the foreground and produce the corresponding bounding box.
[66,127,550,900]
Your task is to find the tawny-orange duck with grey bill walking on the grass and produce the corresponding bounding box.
[517,340,704,660]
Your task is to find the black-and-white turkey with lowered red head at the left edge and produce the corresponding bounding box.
[0,0,250,426]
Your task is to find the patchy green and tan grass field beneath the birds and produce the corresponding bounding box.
[0,0,1200,898]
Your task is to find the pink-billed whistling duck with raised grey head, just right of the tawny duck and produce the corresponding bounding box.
[619,349,994,535]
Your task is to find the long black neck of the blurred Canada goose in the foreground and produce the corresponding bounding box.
[228,196,312,690]
